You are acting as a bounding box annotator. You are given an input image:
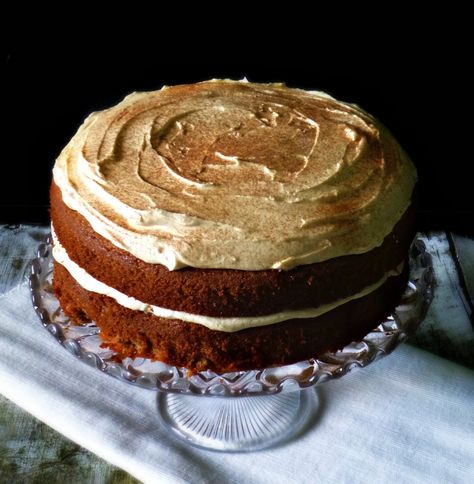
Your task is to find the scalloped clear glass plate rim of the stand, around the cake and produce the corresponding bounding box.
[30,236,434,396]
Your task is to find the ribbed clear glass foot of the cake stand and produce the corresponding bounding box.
[158,388,318,452]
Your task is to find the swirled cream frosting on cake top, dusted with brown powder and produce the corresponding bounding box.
[54,80,416,270]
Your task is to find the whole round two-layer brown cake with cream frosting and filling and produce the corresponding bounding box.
[51,80,416,372]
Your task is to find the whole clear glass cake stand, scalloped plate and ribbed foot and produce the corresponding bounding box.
[30,237,434,451]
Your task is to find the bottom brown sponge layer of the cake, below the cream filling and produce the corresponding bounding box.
[54,262,408,373]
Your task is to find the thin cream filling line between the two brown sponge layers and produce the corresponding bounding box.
[52,229,404,332]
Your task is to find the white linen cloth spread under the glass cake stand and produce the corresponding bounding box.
[0,284,474,484]
